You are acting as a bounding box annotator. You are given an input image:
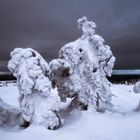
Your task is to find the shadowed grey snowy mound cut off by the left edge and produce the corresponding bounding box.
[0,99,21,127]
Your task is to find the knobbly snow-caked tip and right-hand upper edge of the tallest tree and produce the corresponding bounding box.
[78,17,115,76]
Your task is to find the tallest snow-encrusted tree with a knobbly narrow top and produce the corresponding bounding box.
[49,17,115,111]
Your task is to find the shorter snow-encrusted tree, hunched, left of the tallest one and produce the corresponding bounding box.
[8,48,61,129]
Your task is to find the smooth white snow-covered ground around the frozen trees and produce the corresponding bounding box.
[0,84,140,140]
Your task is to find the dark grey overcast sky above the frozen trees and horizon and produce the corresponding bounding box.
[0,0,140,71]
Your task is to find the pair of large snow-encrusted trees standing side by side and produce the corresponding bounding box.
[0,17,115,129]
